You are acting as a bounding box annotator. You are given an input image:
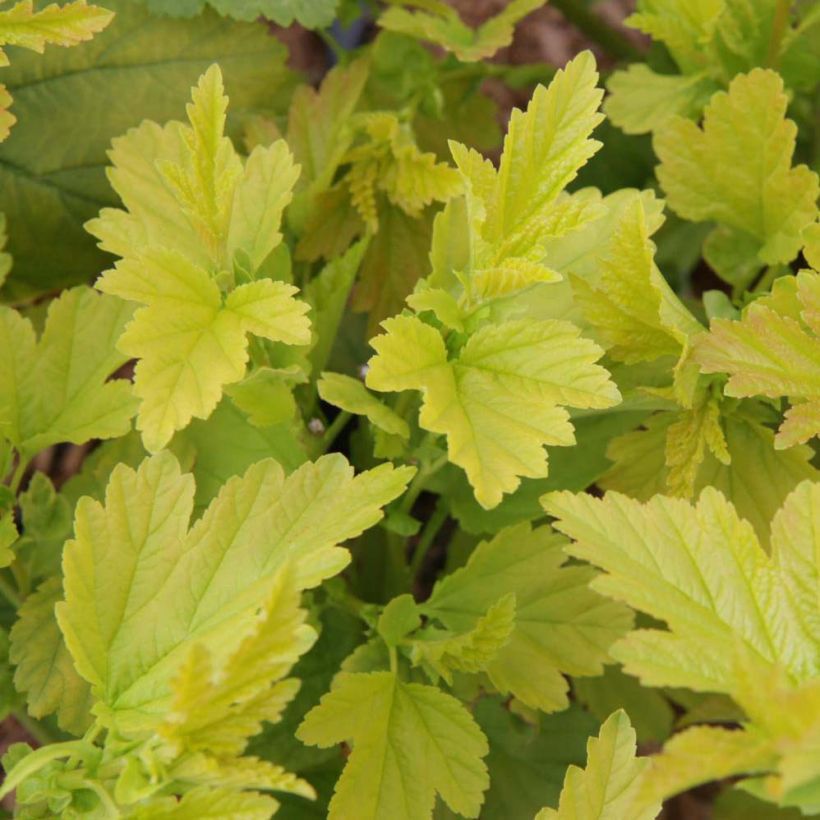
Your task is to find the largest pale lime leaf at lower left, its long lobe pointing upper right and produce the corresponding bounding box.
[57,452,409,727]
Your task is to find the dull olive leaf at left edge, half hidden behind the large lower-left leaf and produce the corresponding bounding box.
[9,578,91,735]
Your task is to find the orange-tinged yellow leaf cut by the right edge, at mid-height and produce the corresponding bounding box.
[694,270,820,448]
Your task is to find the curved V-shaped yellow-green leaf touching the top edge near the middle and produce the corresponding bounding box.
[379,0,545,62]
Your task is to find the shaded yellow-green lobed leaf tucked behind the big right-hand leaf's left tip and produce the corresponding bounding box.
[422,523,631,711]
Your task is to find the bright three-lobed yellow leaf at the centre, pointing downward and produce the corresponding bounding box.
[367,316,620,508]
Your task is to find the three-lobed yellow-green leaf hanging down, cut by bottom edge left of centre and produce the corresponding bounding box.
[297,672,489,820]
